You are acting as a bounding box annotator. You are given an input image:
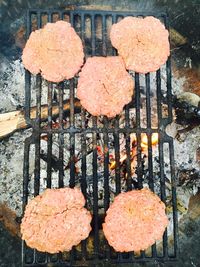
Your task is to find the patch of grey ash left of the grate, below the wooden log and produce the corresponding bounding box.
[0,130,34,216]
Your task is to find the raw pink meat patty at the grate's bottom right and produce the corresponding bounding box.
[103,189,168,252]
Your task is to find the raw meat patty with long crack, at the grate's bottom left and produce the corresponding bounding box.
[21,188,92,253]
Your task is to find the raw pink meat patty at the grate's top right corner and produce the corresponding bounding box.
[110,17,170,73]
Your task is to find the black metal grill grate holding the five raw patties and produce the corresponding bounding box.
[22,9,178,266]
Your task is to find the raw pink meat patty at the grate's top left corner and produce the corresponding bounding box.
[22,21,84,82]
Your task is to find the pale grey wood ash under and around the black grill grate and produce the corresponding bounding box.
[0,55,200,241]
